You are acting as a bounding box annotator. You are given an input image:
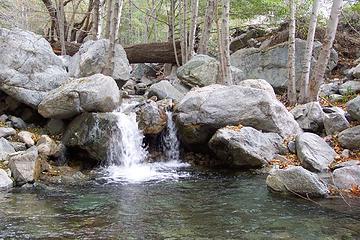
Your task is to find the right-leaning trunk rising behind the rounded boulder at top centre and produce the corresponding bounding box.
[198,0,217,54]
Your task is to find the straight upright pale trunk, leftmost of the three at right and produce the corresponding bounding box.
[287,0,297,106]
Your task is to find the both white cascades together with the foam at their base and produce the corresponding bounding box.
[106,104,188,182]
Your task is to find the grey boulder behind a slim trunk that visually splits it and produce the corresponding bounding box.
[69,39,131,85]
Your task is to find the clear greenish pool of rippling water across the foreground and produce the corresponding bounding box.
[0,168,360,239]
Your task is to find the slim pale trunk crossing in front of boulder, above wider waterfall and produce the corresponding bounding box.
[103,0,122,76]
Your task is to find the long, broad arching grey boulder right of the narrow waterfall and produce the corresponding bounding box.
[176,85,301,145]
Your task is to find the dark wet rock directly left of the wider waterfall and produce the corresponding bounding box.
[62,113,118,162]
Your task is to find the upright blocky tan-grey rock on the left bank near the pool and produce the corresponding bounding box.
[9,146,38,186]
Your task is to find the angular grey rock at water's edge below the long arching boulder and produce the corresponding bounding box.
[209,127,285,168]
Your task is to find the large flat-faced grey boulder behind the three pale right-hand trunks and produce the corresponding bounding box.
[231,39,338,90]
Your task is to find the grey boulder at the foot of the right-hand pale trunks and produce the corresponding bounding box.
[290,102,324,133]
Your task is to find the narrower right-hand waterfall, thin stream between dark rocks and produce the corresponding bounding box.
[161,111,180,161]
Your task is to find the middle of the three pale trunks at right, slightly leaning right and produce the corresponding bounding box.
[299,0,320,103]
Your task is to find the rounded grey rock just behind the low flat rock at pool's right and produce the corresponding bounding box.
[296,133,336,172]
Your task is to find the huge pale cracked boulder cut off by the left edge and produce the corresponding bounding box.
[0,28,68,108]
